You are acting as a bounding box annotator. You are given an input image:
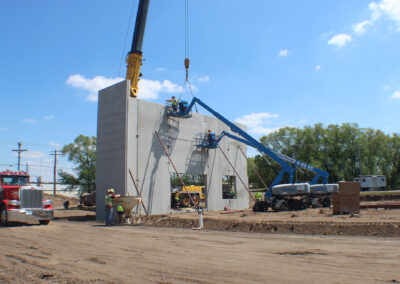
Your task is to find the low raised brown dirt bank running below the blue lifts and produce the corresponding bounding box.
[144,206,400,237]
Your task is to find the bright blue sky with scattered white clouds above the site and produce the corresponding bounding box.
[0,0,400,181]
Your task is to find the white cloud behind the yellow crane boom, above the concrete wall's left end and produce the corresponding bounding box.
[66,74,180,102]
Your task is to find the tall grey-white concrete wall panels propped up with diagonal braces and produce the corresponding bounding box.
[96,81,249,219]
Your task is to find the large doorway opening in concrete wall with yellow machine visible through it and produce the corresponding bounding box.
[170,173,207,209]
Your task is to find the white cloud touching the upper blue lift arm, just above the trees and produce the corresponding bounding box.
[235,112,279,135]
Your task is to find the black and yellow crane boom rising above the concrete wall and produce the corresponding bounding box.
[126,0,150,98]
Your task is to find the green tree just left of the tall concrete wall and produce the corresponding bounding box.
[59,135,97,195]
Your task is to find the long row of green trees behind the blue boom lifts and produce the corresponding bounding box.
[248,123,400,189]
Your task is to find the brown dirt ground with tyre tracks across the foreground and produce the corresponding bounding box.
[0,203,400,284]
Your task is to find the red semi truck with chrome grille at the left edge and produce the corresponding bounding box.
[0,171,53,226]
